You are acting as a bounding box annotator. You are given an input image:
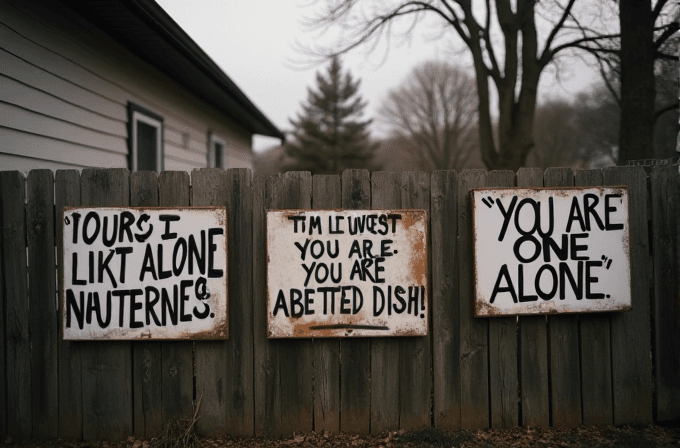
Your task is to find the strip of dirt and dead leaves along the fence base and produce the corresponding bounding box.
[3,425,680,448]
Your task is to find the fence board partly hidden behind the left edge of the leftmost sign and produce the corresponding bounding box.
[55,170,83,440]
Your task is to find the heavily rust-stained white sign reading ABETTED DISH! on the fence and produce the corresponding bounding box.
[267,210,428,338]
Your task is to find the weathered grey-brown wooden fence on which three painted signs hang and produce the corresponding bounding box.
[0,166,680,440]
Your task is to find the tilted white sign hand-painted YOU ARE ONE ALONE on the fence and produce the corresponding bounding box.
[471,187,631,317]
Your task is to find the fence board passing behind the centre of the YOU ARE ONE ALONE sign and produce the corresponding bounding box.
[543,168,582,428]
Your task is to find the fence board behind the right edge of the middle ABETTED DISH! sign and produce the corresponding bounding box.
[399,172,432,430]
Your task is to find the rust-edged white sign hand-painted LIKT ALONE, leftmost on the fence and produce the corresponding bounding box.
[61,207,229,340]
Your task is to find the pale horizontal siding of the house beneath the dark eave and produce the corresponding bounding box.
[0,0,252,171]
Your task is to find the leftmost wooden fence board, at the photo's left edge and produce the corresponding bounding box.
[0,171,33,439]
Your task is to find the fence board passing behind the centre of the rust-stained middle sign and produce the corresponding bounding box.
[340,170,371,434]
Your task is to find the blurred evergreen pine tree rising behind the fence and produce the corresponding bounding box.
[286,57,377,174]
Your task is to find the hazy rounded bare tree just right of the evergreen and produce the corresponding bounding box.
[378,62,477,171]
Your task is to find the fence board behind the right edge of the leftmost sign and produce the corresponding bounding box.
[191,168,232,436]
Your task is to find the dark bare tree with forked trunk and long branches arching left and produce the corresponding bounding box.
[298,0,620,170]
